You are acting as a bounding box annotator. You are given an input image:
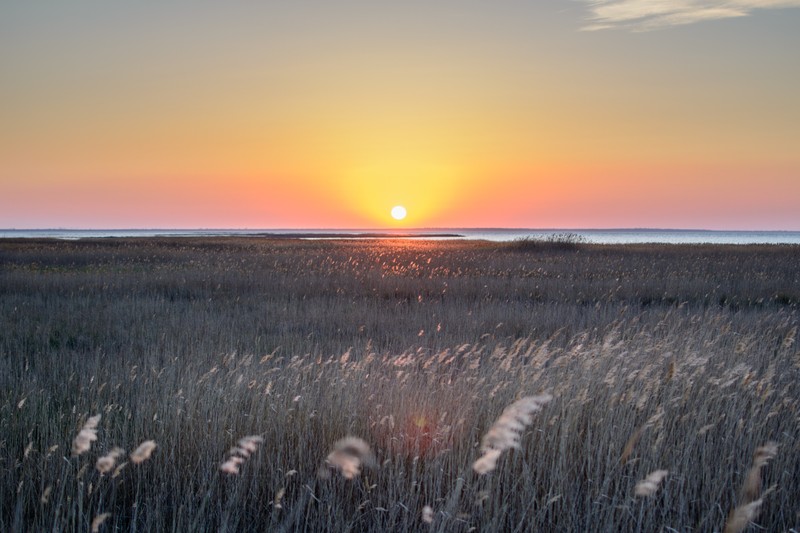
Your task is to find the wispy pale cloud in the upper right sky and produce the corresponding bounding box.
[581,0,800,31]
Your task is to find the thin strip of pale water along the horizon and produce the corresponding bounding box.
[0,228,800,244]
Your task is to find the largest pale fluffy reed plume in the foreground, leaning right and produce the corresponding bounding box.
[472,394,553,475]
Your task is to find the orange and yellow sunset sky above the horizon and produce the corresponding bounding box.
[0,0,800,231]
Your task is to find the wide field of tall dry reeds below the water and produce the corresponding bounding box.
[0,238,800,532]
